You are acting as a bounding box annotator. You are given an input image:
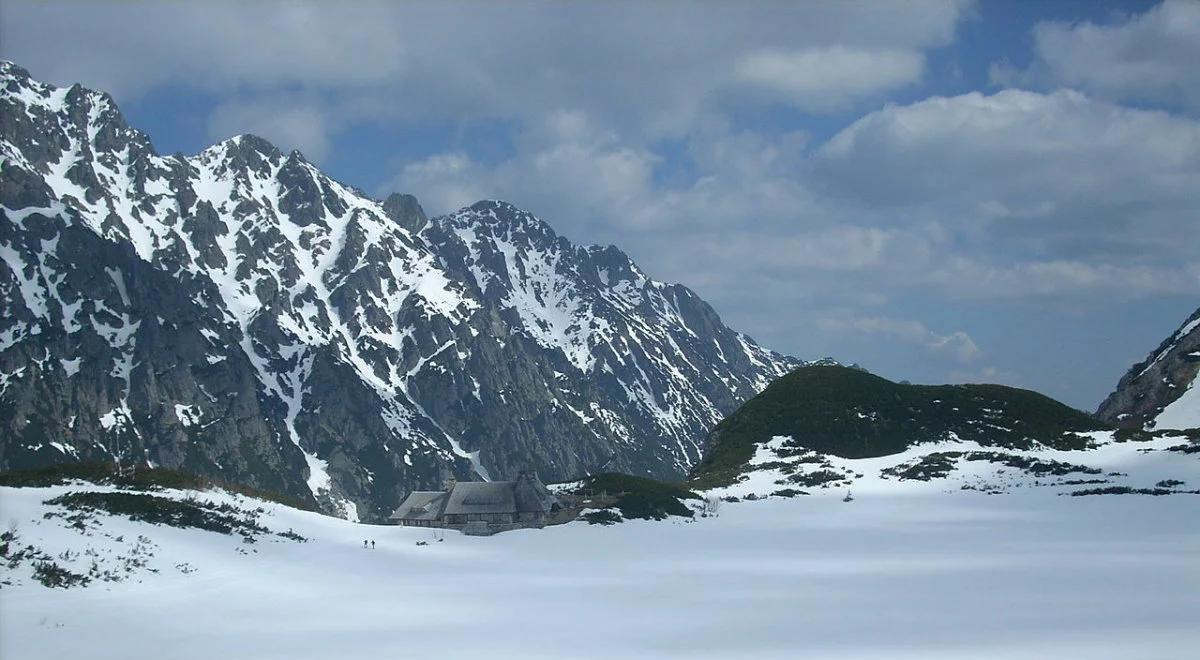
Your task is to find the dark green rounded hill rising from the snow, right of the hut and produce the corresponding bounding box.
[691,366,1110,488]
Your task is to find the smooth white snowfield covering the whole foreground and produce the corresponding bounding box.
[0,487,1200,660]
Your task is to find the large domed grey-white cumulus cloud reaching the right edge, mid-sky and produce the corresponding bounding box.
[811,90,1200,282]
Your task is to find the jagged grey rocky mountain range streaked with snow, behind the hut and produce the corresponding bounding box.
[0,62,802,517]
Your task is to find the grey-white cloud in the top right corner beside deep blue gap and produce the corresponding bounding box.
[992,0,1200,110]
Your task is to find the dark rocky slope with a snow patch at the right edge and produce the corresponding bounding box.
[1096,310,1200,430]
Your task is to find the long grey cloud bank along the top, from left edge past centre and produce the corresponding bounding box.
[0,0,968,134]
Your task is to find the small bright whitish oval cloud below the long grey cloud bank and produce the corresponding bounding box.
[736,46,925,112]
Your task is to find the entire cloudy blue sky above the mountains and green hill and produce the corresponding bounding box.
[0,0,1200,409]
